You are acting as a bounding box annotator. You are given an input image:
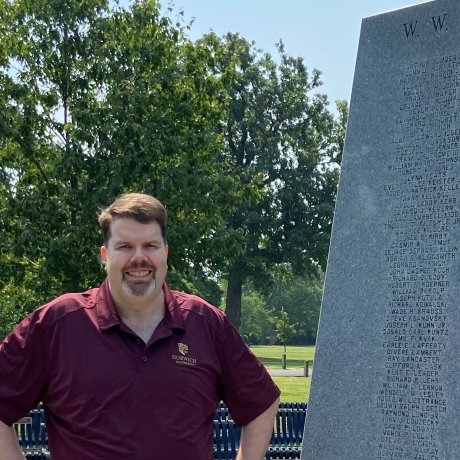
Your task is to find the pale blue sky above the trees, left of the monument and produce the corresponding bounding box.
[162,0,425,108]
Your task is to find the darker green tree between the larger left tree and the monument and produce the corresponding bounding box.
[202,34,345,327]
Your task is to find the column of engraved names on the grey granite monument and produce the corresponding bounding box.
[375,54,460,460]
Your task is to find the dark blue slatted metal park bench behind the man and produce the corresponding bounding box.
[14,402,307,460]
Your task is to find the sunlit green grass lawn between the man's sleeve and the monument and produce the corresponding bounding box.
[251,345,315,402]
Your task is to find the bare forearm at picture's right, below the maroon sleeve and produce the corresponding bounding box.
[236,398,279,460]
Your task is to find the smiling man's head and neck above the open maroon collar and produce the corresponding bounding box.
[99,207,168,343]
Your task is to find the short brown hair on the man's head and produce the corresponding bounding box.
[98,193,167,244]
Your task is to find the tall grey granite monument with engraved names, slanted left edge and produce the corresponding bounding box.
[302,0,460,460]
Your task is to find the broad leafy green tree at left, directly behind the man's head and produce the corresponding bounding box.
[0,0,246,330]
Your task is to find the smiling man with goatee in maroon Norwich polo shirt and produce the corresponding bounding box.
[0,193,279,460]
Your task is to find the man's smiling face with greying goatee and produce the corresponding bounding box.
[101,218,168,302]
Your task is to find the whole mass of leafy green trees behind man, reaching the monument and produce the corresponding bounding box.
[0,0,347,340]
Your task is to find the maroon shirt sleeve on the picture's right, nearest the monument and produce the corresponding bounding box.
[219,318,280,426]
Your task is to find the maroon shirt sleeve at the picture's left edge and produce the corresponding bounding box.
[0,311,49,425]
